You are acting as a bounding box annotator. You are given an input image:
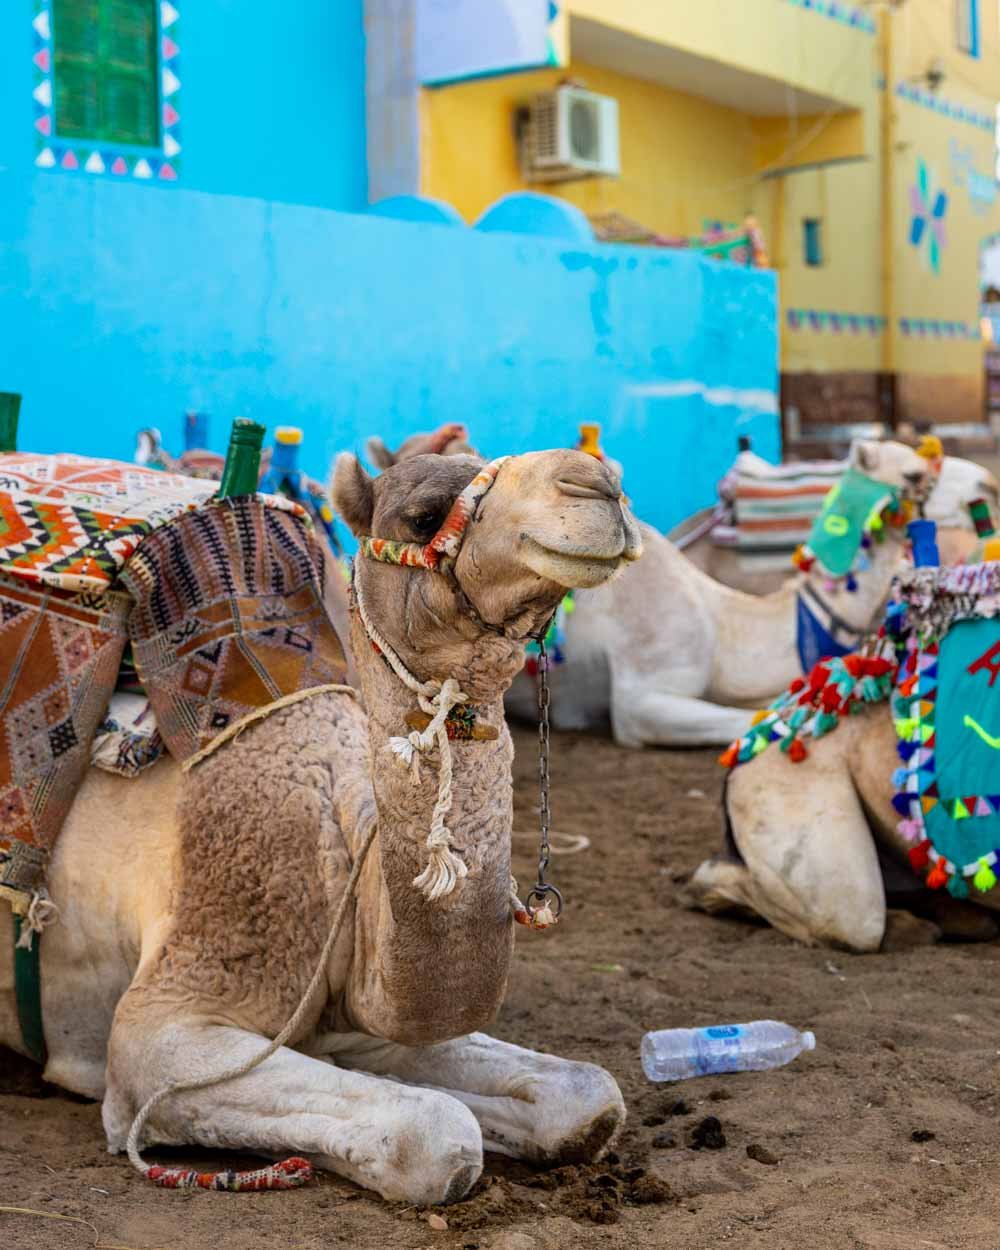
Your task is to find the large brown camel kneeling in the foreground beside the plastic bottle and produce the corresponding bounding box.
[0,451,640,1204]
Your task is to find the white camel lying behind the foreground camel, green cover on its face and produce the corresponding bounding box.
[508,443,949,748]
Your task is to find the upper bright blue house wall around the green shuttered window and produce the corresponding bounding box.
[0,0,368,211]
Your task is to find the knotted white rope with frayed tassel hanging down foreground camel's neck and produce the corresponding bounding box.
[354,584,469,903]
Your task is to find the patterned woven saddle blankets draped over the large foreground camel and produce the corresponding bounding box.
[0,453,346,910]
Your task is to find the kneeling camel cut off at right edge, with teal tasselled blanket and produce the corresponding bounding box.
[689,557,1000,951]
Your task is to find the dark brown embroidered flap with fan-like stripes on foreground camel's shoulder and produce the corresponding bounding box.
[121,496,346,761]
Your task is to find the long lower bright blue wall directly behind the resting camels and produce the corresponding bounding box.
[0,173,779,528]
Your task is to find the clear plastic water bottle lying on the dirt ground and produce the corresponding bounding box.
[641,1020,816,1081]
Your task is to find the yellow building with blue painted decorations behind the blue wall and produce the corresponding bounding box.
[405,0,1000,426]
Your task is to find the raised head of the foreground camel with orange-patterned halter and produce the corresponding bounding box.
[333,451,641,676]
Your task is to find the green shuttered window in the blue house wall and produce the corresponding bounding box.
[53,0,160,148]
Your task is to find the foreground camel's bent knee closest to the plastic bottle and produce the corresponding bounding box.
[520,1060,625,1164]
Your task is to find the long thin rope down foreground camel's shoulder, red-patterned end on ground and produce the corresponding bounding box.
[125,820,379,1191]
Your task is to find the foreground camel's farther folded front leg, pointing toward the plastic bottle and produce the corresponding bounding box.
[324,1033,625,1164]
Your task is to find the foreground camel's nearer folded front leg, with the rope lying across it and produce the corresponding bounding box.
[103,1023,483,1204]
